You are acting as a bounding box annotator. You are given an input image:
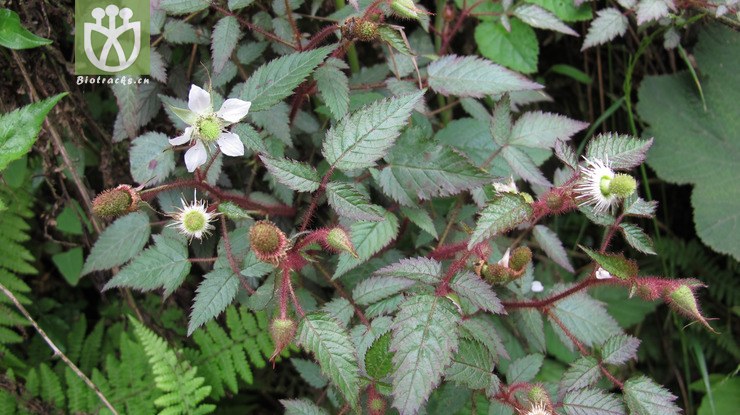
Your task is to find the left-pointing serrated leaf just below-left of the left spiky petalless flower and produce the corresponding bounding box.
[103,229,191,297]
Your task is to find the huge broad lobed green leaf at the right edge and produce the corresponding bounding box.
[637,24,740,259]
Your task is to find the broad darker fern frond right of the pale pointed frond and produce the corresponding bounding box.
[185,306,288,399]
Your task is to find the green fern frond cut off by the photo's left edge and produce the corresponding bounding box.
[0,184,36,369]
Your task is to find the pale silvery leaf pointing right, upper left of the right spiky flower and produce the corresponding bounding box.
[509,111,588,148]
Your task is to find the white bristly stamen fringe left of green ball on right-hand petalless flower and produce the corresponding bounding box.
[575,157,619,213]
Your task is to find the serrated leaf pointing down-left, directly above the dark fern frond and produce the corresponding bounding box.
[188,268,239,336]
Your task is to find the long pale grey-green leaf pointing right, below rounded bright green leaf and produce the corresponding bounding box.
[427,54,542,98]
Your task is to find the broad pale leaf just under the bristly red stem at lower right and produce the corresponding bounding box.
[550,292,622,350]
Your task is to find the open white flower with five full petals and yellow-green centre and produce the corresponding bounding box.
[170,85,252,172]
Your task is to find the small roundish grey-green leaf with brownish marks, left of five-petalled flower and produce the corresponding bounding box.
[129,132,175,186]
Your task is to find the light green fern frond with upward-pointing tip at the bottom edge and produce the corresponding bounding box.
[130,318,216,415]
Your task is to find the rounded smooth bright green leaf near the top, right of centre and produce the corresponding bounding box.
[475,18,540,73]
